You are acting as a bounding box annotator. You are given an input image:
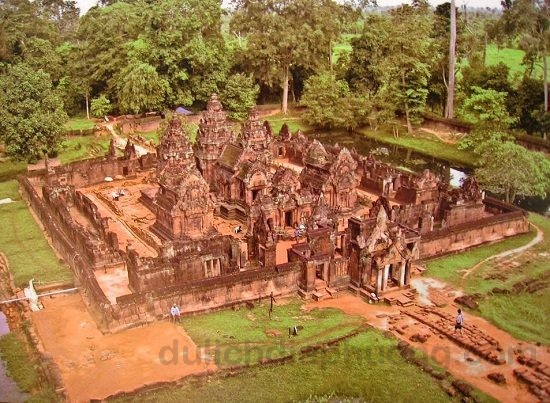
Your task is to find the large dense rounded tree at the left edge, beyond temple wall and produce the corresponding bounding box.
[0,63,67,160]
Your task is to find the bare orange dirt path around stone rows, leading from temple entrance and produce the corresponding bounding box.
[308,285,550,402]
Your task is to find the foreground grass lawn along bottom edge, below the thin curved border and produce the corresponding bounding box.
[113,332,466,402]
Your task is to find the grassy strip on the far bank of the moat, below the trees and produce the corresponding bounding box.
[358,128,476,166]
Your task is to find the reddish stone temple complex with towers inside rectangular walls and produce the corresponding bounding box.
[20,95,528,330]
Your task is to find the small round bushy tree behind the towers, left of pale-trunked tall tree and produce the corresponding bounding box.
[220,73,260,120]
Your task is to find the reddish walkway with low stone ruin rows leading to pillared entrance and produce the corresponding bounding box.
[308,286,550,402]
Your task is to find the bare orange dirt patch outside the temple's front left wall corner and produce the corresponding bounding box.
[31,294,215,402]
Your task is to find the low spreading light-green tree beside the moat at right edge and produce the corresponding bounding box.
[475,141,550,203]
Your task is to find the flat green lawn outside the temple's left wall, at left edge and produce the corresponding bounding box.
[0,180,72,286]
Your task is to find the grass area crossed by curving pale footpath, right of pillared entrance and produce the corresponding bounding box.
[427,213,550,345]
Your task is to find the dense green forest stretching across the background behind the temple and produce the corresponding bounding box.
[0,0,550,186]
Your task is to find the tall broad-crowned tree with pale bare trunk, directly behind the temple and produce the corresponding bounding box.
[231,0,360,113]
